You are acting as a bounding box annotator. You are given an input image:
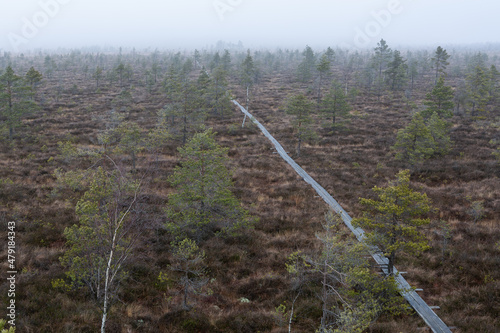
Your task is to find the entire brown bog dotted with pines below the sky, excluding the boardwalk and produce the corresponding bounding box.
[0,40,500,332]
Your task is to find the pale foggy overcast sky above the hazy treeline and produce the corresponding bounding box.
[0,0,500,51]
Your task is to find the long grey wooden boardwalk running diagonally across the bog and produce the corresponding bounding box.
[232,100,451,333]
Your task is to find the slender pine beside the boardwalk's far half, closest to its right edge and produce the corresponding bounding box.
[285,94,315,156]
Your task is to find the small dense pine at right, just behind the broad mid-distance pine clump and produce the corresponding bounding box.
[421,76,455,119]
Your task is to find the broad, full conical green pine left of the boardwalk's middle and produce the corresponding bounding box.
[166,129,252,240]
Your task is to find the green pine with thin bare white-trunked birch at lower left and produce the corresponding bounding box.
[58,167,139,327]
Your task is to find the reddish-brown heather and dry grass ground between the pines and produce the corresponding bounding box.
[0,53,500,332]
